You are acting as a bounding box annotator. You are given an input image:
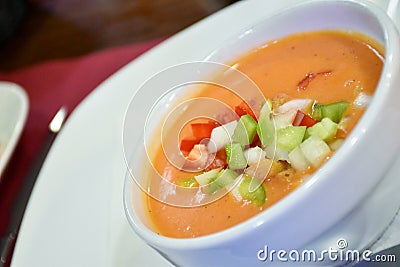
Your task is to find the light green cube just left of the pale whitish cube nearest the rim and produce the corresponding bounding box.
[276,126,306,151]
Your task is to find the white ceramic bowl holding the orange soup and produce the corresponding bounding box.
[124,0,400,266]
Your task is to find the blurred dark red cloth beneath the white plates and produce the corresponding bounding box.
[0,39,162,253]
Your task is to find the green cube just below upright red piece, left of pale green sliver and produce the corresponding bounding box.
[232,114,257,147]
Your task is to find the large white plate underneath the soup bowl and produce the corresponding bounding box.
[12,0,398,267]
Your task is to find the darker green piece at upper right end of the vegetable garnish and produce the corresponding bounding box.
[311,101,349,123]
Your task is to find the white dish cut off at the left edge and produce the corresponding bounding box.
[0,82,29,180]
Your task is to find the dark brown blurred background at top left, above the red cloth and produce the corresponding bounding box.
[0,0,234,71]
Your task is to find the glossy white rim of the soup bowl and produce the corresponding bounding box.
[123,0,400,250]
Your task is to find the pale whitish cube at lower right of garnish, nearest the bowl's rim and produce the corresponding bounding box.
[300,135,331,167]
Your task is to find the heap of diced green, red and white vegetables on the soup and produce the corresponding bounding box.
[177,97,356,206]
